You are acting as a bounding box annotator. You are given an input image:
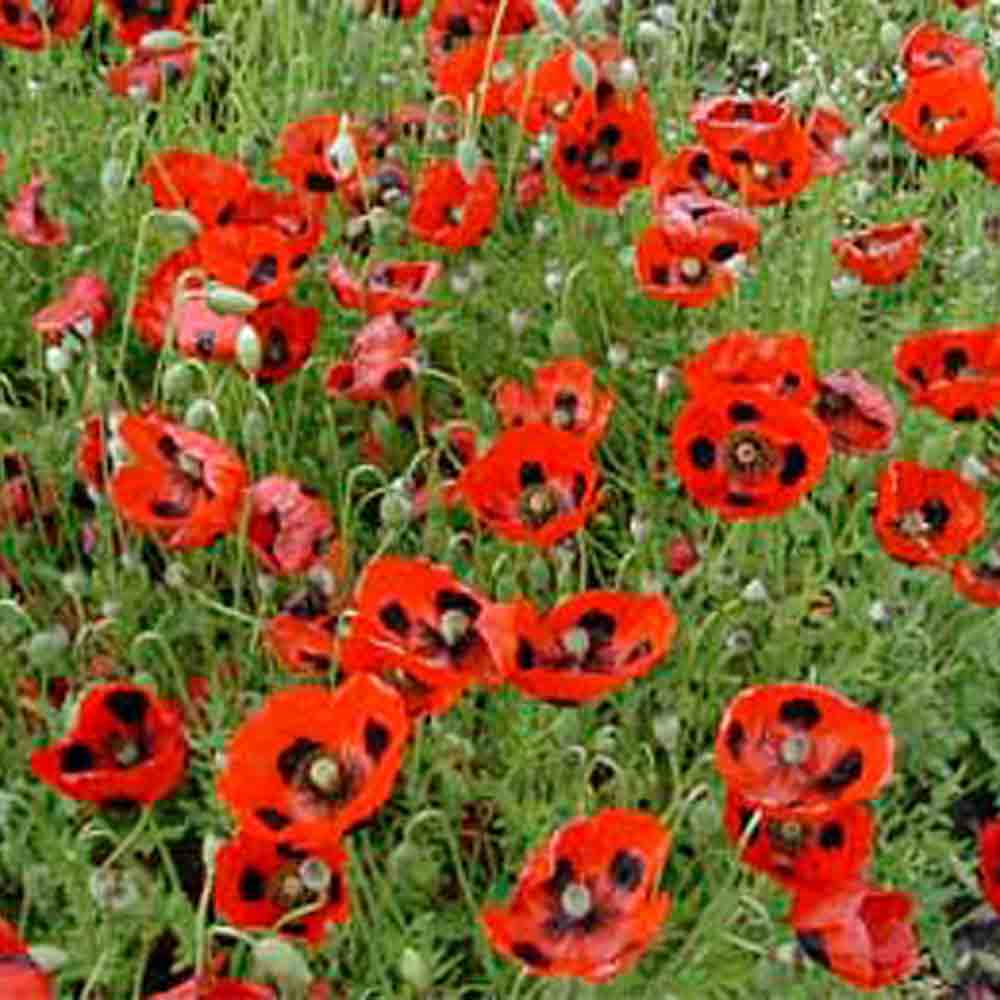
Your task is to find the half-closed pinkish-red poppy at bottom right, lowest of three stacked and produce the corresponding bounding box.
[788,879,920,991]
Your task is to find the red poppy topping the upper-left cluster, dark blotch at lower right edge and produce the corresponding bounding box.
[139,149,250,227]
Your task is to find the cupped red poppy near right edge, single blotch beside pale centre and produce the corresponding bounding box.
[874,461,986,566]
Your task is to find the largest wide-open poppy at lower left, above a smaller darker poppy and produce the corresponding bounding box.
[217,675,410,848]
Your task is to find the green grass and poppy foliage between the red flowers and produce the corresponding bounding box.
[0,0,1000,1000]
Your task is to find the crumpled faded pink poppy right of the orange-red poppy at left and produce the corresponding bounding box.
[247,476,333,576]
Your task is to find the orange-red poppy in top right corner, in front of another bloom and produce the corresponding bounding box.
[884,57,996,156]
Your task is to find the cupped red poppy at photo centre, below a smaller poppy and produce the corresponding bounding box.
[455,424,599,548]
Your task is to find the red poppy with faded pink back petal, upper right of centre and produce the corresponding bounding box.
[635,193,760,308]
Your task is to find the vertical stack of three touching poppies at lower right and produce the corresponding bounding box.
[715,684,919,990]
